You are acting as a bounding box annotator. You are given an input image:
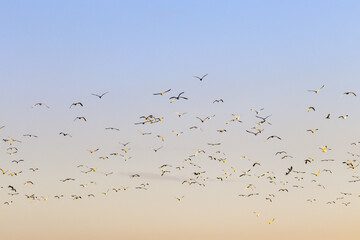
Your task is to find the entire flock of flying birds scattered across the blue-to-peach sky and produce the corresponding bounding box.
[0,74,360,224]
